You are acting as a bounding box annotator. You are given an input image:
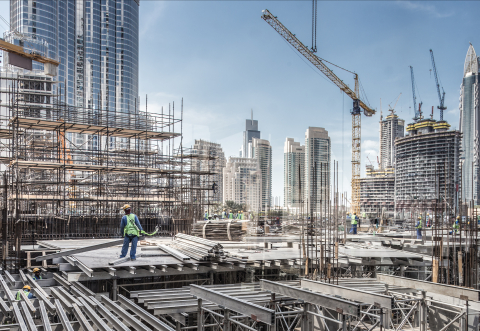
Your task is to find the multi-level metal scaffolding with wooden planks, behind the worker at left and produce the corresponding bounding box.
[0,72,216,269]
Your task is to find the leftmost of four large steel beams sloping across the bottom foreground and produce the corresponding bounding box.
[190,284,275,325]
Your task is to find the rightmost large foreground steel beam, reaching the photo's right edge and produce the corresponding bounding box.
[377,274,480,301]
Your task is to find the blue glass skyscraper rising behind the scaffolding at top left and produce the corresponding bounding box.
[10,0,139,113]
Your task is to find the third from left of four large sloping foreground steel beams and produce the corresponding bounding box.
[300,279,394,309]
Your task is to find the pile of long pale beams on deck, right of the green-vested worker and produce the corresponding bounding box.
[169,233,226,261]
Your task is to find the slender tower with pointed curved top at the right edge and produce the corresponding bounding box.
[459,44,480,205]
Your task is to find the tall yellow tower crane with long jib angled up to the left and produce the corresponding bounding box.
[262,9,375,213]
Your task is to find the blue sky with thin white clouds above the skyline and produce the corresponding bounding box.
[0,0,480,206]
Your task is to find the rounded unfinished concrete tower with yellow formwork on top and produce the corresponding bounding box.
[395,119,462,216]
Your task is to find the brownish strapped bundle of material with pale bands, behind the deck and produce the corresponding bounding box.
[192,220,246,241]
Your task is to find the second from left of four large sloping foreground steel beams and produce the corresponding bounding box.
[260,279,361,317]
